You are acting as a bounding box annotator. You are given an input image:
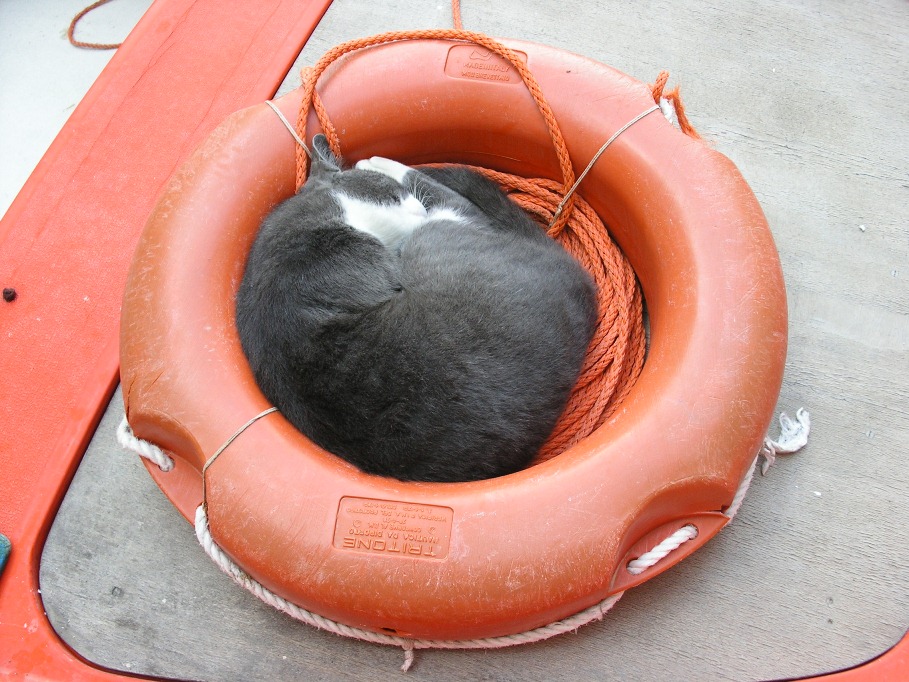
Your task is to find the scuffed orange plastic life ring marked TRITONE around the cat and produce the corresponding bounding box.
[121,40,787,639]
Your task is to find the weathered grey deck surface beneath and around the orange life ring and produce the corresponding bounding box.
[0,0,909,680]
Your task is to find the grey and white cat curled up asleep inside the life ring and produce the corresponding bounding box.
[237,136,597,481]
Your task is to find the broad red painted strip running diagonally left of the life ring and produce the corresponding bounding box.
[0,0,331,680]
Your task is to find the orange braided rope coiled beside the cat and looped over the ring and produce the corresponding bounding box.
[296,7,697,463]
